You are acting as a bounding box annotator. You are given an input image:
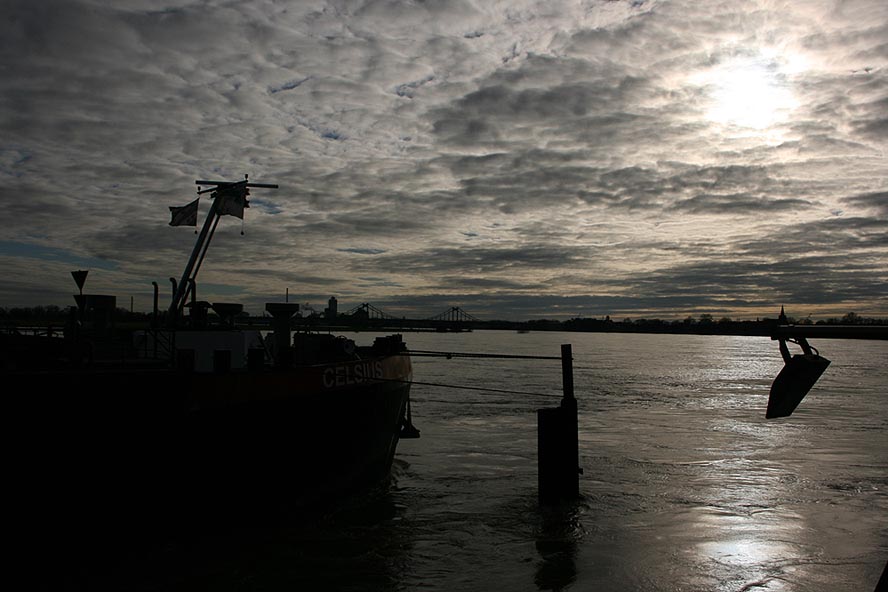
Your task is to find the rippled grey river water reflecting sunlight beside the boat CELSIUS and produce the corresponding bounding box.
[80,331,888,592]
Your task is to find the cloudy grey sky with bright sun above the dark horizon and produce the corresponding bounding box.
[0,0,888,320]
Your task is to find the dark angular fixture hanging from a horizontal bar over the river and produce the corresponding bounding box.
[765,338,829,419]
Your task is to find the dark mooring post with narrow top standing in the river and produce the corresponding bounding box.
[537,344,580,504]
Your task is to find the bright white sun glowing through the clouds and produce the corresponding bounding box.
[698,55,798,132]
